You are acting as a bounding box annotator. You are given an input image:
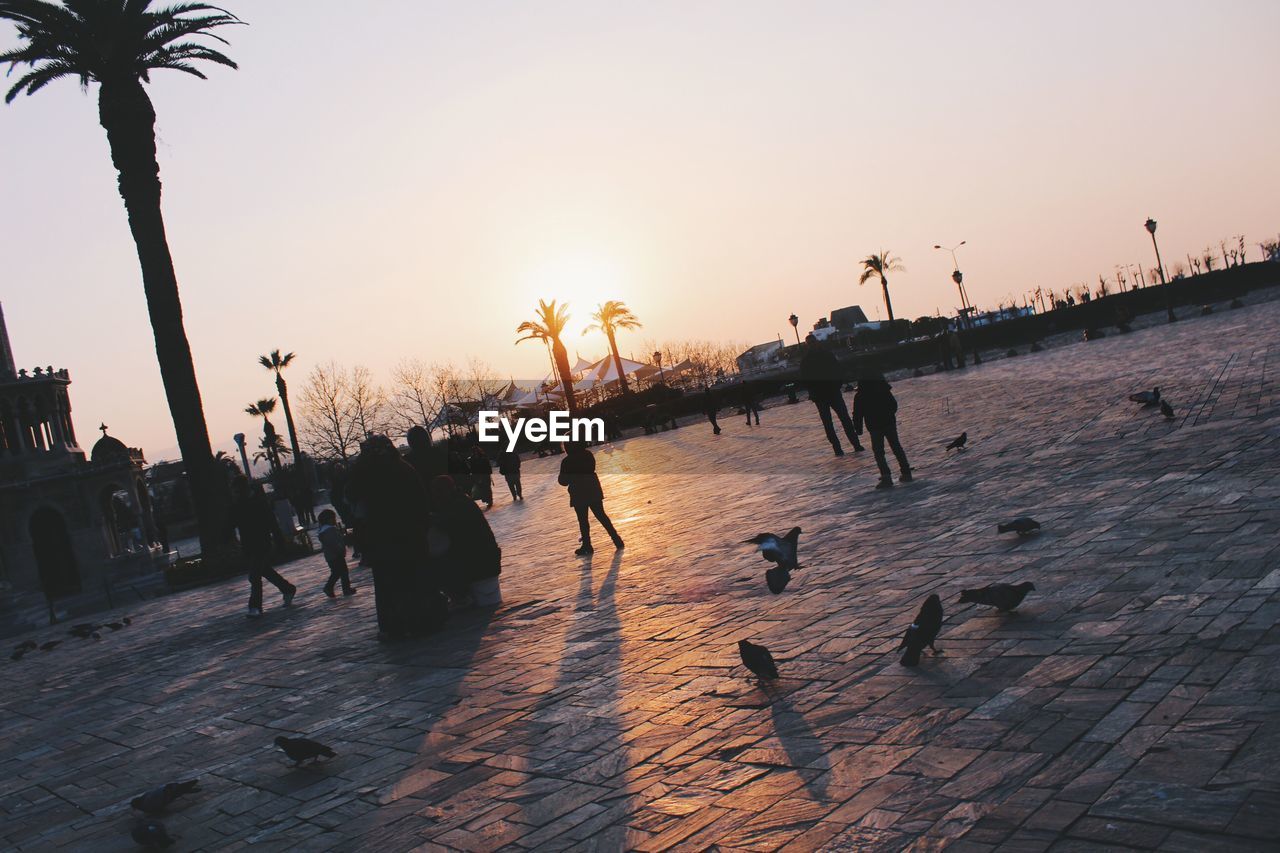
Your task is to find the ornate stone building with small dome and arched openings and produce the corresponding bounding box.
[0,302,166,634]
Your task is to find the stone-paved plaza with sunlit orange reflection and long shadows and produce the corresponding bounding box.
[0,295,1280,850]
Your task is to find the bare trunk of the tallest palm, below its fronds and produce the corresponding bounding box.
[99,79,230,555]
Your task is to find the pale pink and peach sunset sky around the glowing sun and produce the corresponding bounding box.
[0,0,1280,461]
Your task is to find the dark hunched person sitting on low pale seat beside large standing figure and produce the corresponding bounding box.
[431,475,502,603]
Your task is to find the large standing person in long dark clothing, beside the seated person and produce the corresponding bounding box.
[351,435,443,639]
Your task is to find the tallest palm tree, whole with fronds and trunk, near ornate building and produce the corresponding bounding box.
[0,0,241,555]
